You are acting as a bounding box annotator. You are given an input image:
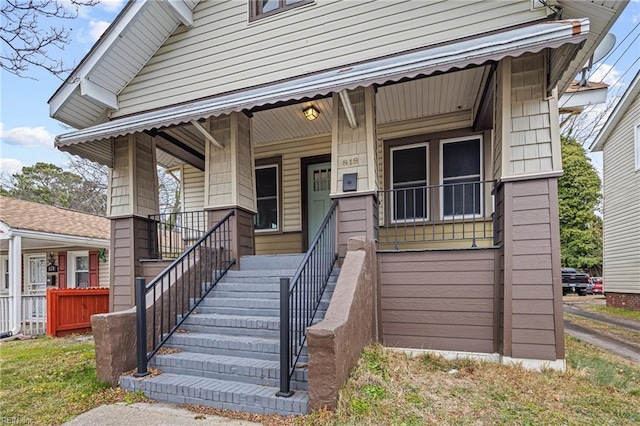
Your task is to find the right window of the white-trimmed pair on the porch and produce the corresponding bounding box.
[440,136,483,218]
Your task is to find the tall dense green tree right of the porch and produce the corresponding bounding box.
[558,136,602,271]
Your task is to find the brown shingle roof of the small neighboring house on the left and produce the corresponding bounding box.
[0,196,111,240]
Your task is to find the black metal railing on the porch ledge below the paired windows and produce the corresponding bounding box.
[378,180,496,250]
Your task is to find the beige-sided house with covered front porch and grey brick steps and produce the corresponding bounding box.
[49,0,626,412]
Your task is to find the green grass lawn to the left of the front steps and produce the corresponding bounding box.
[0,337,145,425]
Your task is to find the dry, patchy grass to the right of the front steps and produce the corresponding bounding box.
[298,338,640,425]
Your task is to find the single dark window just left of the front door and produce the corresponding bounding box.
[254,164,280,231]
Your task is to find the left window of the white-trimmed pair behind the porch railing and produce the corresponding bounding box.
[390,143,429,221]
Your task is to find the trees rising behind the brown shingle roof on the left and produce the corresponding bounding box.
[1,163,107,215]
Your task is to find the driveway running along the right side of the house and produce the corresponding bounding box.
[563,295,640,363]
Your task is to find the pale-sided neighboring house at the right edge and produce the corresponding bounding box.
[591,69,640,310]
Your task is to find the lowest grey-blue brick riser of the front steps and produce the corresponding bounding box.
[121,376,307,415]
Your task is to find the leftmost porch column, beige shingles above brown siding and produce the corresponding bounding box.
[107,133,159,312]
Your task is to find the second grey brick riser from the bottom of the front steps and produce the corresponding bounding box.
[149,360,308,391]
